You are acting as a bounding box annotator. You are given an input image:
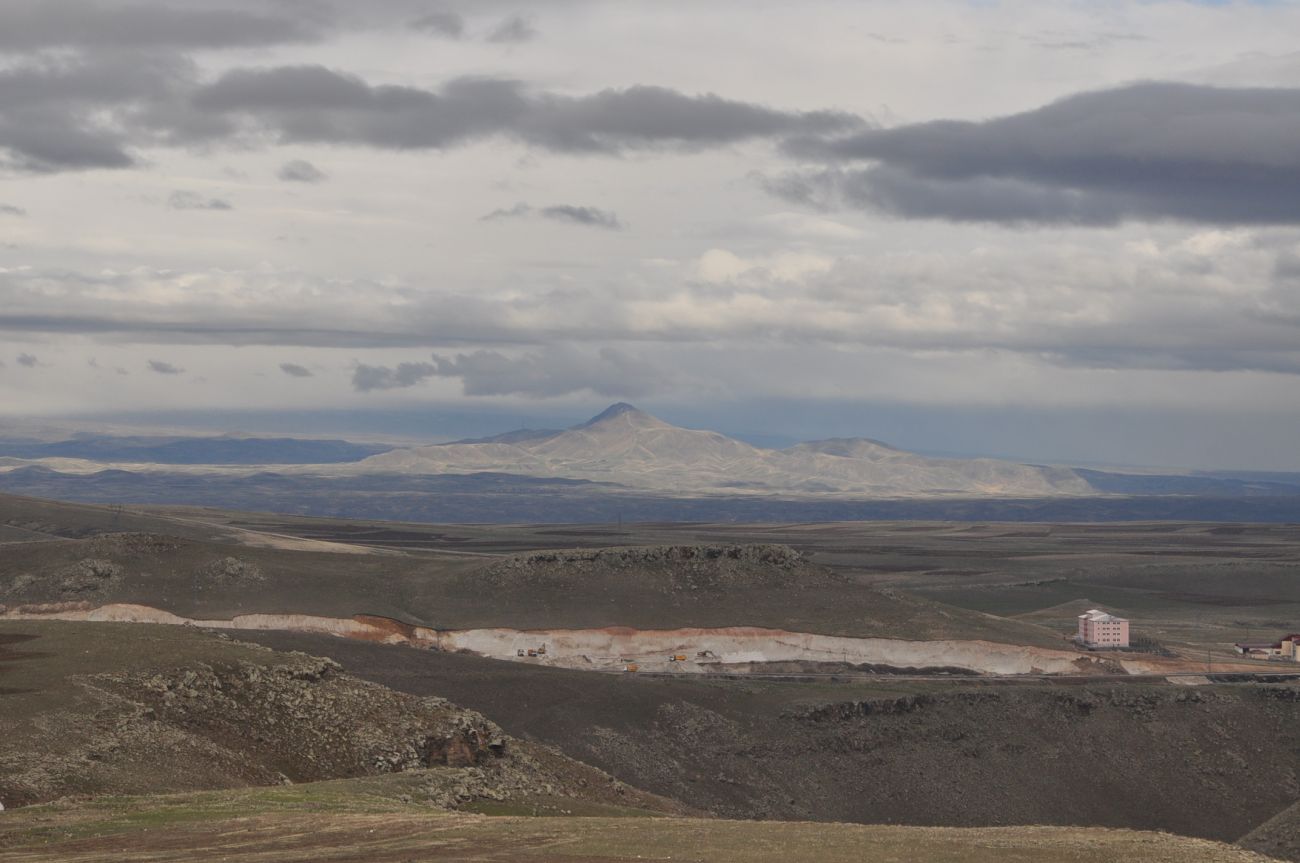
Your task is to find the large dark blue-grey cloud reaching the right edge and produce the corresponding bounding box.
[780,83,1300,225]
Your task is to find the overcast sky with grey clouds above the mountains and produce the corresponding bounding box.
[0,0,1300,470]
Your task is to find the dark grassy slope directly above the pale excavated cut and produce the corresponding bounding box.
[0,534,1061,647]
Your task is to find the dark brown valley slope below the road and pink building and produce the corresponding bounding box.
[250,633,1300,841]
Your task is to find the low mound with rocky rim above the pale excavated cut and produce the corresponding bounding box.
[471,543,842,594]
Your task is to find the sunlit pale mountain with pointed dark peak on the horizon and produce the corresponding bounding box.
[351,403,1097,498]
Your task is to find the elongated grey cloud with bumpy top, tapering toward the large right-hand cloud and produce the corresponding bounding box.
[194,66,857,153]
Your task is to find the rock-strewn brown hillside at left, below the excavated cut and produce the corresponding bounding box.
[0,624,683,811]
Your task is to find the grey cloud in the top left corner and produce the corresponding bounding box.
[0,0,319,52]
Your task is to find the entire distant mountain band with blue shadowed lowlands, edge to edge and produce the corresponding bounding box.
[0,404,1300,522]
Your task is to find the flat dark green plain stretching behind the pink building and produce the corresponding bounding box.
[114,512,1300,645]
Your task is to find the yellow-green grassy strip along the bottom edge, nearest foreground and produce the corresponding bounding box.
[0,782,1268,863]
